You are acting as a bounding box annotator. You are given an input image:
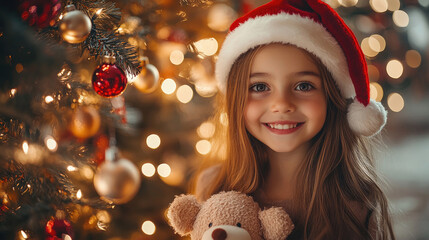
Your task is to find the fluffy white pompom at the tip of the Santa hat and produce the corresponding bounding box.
[347,98,387,136]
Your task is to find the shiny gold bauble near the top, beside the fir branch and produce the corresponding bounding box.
[59,5,92,43]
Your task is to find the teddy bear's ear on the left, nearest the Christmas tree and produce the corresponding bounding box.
[167,194,201,236]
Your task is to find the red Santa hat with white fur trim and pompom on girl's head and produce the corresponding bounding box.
[216,0,387,136]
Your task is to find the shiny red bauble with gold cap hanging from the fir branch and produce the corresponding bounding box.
[92,56,128,98]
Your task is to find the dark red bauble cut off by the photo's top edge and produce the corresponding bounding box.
[18,0,61,28]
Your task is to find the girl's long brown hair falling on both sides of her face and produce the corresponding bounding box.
[192,46,394,239]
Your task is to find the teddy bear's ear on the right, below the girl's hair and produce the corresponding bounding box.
[259,207,294,240]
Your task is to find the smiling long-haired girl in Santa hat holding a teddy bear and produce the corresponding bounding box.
[195,0,394,239]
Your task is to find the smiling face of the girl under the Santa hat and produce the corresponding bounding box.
[244,44,327,152]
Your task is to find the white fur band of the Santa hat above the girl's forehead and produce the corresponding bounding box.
[216,12,356,98]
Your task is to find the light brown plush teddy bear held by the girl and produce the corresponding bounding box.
[167,191,294,240]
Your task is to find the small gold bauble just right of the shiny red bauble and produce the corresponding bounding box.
[133,58,159,93]
